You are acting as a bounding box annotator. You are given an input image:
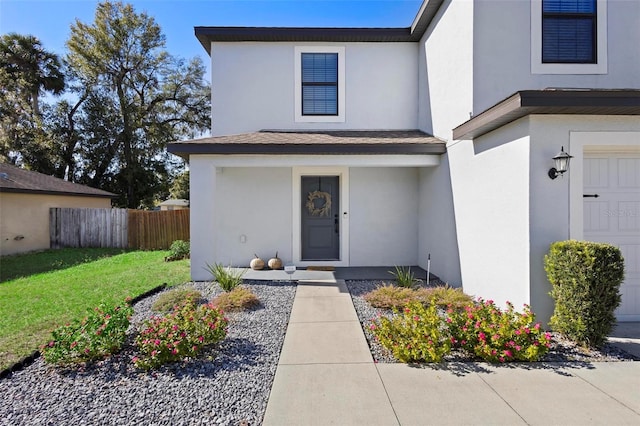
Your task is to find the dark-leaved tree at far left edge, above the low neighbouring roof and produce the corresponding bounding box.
[0,33,65,167]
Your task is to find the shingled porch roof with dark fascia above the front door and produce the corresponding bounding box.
[167,130,446,157]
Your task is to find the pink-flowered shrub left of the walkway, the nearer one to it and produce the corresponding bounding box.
[133,301,228,370]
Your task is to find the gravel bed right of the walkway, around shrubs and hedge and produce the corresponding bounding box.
[346,281,636,363]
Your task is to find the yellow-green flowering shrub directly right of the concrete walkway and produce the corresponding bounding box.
[370,302,451,362]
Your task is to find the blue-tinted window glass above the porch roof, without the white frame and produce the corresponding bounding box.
[301,53,338,115]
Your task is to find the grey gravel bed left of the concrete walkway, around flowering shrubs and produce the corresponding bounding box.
[0,281,296,425]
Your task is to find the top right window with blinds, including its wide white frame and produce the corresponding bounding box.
[531,0,608,74]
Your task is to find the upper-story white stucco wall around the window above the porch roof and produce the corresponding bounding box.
[211,42,418,136]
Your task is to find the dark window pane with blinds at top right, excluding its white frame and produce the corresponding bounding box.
[542,0,597,64]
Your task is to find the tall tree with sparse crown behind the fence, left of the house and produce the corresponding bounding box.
[67,1,210,208]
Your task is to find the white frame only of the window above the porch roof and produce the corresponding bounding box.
[293,46,345,123]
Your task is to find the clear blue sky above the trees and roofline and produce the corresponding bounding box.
[0,0,422,70]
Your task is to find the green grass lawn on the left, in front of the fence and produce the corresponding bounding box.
[0,249,189,369]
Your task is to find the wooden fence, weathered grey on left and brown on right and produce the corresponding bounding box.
[49,208,189,250]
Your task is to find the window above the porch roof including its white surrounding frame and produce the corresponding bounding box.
[294,45,345,123]
